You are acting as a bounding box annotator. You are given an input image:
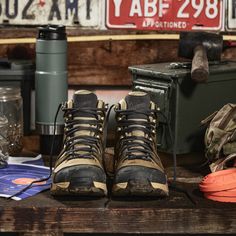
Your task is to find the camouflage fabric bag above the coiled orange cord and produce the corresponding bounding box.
[202,103,236,172]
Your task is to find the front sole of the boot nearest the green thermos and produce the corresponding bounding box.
[51,182,107,197]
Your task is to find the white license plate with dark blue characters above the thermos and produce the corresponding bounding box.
[0,0,101,27]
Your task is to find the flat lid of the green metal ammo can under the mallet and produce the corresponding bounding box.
[129,61,236,82]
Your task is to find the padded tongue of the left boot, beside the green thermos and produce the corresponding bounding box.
[73,90,98,117]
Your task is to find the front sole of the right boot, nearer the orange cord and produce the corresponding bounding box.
[112,180,169,197]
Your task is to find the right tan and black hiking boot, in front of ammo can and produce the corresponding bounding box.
[112,92,168,196]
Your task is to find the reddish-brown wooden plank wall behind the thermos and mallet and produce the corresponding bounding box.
[0,28,236,86]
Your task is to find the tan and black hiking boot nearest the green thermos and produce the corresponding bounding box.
[51,90,107,196]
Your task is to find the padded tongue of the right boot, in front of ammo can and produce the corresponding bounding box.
[125,91,150,119]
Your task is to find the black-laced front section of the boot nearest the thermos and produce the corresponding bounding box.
[59,106,107,160]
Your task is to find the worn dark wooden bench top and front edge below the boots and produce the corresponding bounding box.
[0,184,236,234]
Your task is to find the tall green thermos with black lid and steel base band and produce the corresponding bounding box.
[35,25,68,154]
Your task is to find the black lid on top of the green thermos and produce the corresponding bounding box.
[38,25,66,40]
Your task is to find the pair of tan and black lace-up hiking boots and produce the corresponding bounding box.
[51,90,168,196]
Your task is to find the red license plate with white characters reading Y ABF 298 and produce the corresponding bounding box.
[106,0,224,31]
